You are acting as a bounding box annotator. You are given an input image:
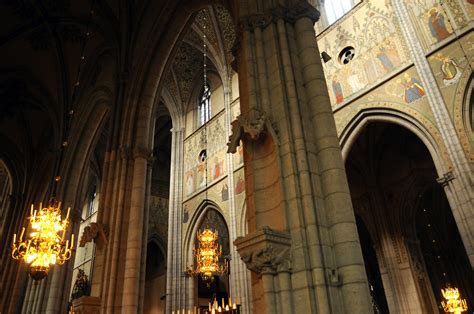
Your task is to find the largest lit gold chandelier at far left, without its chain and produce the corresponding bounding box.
[12,199,74,281]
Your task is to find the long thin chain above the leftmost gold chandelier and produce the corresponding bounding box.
[51,0,95,199]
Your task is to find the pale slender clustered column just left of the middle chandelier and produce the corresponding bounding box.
[166,126,185,313]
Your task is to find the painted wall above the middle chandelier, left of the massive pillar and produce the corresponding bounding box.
[182,83,245,245]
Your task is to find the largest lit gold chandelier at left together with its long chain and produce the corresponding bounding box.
[12,1,94,281]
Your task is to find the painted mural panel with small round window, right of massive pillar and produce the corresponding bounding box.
[318,0,410,106]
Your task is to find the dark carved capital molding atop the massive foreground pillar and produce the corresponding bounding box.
[239,0,320,32]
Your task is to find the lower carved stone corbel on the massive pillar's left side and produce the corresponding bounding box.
[234,227,291,274]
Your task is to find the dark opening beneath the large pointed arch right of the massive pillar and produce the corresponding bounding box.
[346,121,472,313]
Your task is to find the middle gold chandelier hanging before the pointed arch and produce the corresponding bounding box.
[188,228,227,284]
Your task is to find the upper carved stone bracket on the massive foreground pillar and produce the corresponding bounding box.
[227,110,278,154]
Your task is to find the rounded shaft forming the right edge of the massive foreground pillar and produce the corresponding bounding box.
[295,8,371,313]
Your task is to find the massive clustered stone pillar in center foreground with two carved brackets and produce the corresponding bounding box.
[231,1,372,314]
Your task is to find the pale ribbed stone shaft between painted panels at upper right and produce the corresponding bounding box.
[392,1,474,267]
